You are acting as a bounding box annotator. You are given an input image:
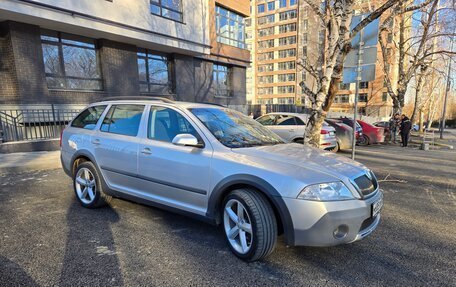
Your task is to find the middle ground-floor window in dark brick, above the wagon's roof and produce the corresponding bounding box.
[138,49,172,94]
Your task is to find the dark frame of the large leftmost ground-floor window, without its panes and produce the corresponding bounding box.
[40,29,104,91]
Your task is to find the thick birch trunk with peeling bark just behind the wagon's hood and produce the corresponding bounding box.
[298,0,410,146]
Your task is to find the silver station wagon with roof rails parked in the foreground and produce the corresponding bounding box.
[61,98,383,261]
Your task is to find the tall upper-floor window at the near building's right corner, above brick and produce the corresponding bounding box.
[215,6,245,49]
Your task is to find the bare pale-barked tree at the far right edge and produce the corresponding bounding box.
[379,0,455,117]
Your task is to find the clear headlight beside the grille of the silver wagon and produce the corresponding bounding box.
[298,181,355,201]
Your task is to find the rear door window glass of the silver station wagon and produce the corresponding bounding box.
[100,105,144,136]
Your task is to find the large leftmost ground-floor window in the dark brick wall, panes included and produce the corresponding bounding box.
[41,30,103,90]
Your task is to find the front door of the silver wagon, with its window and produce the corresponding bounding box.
[138,106,213,215]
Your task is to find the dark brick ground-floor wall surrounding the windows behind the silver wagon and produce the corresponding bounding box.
[0,21,246,105]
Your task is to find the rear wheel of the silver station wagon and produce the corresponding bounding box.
[73,161,112,208]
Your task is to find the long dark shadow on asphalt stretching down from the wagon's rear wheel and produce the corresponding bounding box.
[59,199,123,286]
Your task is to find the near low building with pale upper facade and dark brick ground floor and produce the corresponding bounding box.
[0,0,250,106]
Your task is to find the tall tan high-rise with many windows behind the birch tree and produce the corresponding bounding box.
[246,0,397,117]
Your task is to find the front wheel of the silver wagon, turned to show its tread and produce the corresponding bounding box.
[223,189,277,262]
